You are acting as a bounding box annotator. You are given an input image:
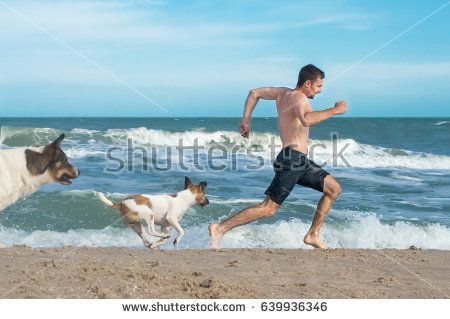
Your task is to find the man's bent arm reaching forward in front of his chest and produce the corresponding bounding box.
[294,99,347,127]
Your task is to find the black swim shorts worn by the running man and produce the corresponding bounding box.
[264,147,330,205]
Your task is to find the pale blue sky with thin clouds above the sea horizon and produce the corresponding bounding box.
[0,0,450,117]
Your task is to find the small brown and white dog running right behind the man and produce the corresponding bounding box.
[97,177,209,248]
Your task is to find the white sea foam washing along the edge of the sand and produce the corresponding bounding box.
[0,214,450,250]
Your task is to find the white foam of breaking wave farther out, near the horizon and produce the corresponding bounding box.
[0,127,450,170]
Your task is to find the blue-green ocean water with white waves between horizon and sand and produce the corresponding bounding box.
[0,118,450,250]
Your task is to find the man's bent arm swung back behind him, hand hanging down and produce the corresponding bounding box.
[239,87,288,138]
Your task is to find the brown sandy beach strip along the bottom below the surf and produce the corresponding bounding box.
[0,246,450,298]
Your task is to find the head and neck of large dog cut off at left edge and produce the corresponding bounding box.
[0,134,80,212]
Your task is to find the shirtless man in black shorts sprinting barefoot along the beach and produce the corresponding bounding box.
[209,64,347,249]
